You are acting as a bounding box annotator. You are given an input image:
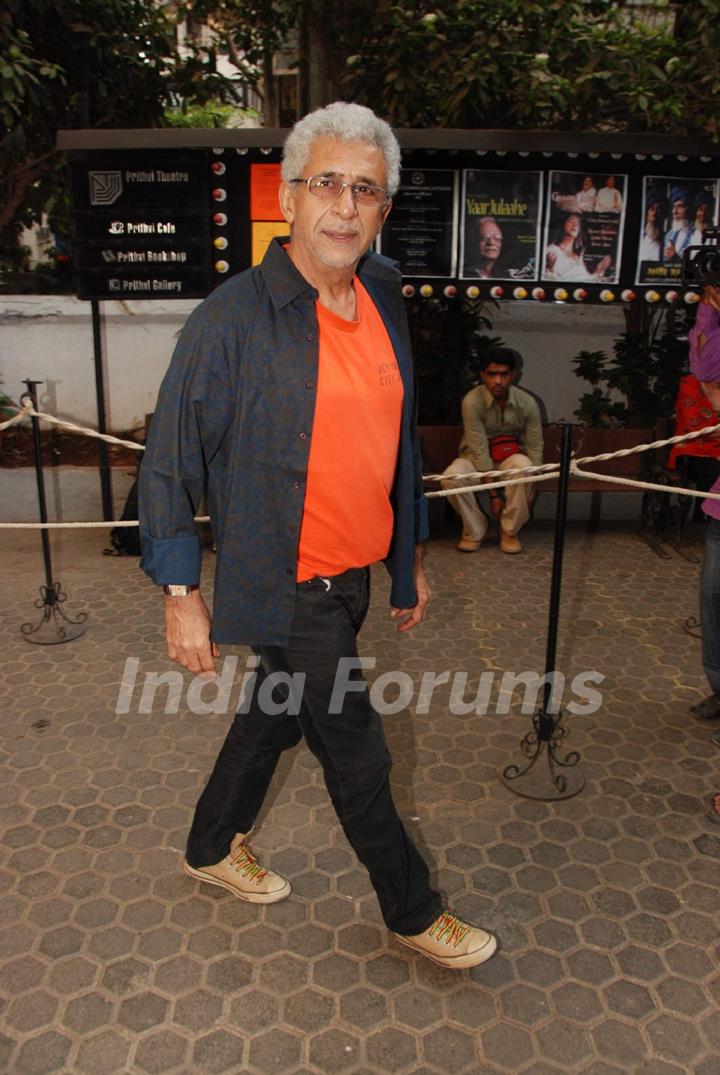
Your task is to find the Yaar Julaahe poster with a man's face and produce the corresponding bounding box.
[460,169,543,281]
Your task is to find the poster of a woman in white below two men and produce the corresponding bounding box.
[543,172,628,284]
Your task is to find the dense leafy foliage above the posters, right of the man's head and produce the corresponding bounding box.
[344,0,720,134]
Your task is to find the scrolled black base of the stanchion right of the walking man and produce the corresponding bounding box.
[500,713,585,802]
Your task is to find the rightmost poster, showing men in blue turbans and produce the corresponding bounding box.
[635,175,718,284]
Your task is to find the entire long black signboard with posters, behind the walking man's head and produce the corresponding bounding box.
[61,130,720,303]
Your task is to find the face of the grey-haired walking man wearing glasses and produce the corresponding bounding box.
[280,137,390,272]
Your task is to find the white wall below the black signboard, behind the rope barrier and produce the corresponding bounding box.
[0,296,624,430]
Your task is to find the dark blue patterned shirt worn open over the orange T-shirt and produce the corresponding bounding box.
[140,240,428,645]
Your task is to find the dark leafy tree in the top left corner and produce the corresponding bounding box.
[0,0,183,265]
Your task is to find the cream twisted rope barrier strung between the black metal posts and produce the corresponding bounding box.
[0,399,720,530]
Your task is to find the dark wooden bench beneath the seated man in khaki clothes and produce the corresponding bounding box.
[418,426,656,527]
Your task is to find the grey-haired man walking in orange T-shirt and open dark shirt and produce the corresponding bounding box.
[140,102,496,968]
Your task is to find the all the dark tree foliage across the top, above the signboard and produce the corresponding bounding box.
[0,0,720,277]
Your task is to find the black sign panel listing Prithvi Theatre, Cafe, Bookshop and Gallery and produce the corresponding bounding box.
[71,151,216,299]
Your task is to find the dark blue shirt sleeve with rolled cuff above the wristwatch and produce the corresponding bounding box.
[139,307,231,586]
